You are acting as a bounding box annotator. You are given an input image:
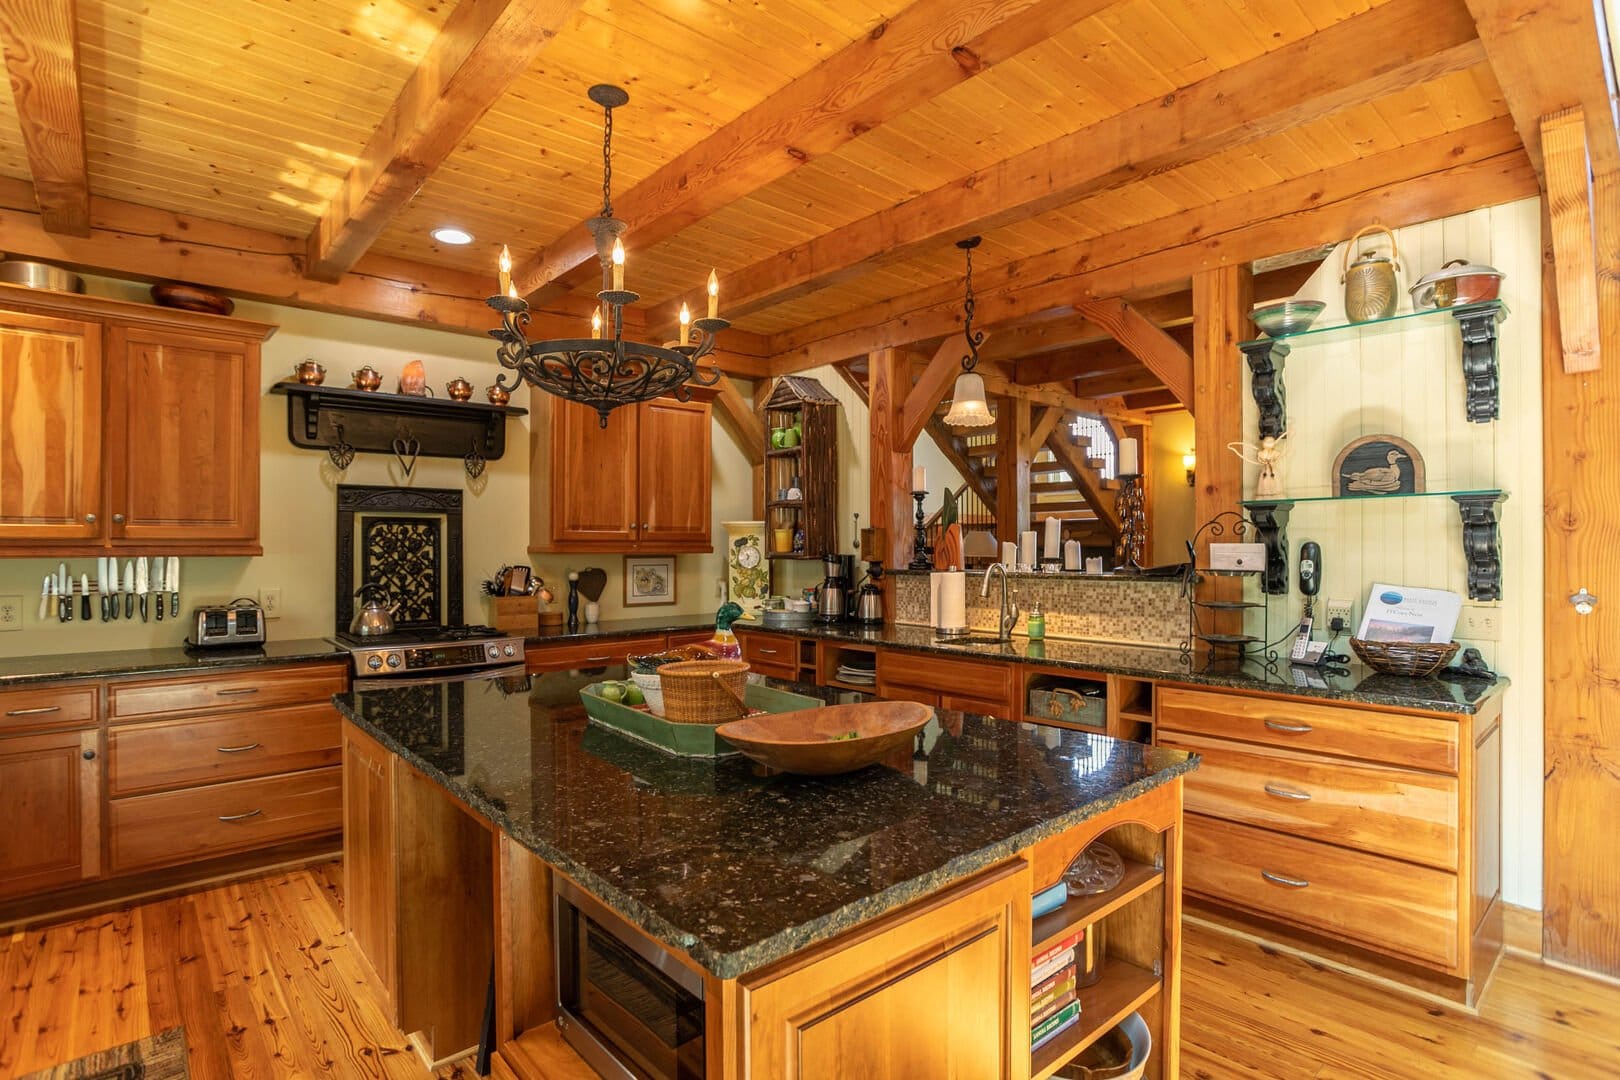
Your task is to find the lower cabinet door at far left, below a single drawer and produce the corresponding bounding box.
[0,729,100,895]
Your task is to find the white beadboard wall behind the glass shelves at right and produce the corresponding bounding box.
[1233,199,1542,908]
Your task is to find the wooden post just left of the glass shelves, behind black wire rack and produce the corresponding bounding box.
[1192,266,1254,633]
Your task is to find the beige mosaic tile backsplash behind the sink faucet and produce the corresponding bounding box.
[893,572,1187,646]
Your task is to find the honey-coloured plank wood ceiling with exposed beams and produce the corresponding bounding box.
[0,0,1587,404]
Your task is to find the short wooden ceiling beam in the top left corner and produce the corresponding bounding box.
[0,0,91,236]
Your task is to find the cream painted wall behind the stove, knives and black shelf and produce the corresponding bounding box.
[0,279,752,656]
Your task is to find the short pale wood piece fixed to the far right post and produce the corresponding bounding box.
[1539,105,1602,372]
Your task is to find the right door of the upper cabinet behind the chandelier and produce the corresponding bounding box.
[638,398,713,551]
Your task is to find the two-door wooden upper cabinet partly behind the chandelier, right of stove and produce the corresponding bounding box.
[530,393,714,554]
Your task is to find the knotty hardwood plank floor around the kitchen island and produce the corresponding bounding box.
[0,863,1620,1080]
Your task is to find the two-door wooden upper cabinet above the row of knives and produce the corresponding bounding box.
[0,285,275,557]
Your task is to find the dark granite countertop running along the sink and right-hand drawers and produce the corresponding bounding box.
[737,623,1510,714]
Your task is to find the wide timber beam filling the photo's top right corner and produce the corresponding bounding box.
[1466,0,1620,175]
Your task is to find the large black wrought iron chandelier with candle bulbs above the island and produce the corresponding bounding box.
[486,84,731,427]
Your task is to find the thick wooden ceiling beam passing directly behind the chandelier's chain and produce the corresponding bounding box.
[512,0,1115,304]
